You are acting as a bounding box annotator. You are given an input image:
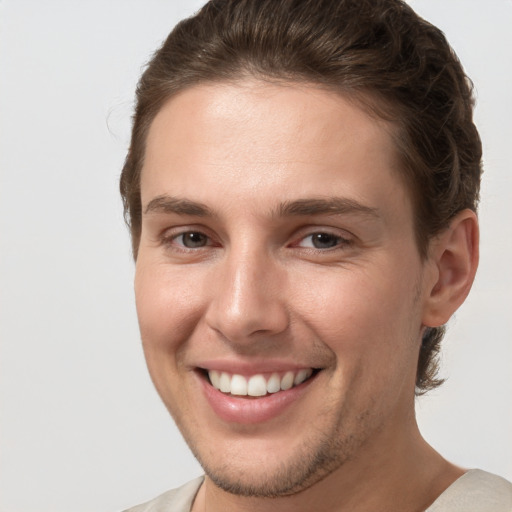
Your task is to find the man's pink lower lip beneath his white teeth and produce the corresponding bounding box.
[200,376,316,425]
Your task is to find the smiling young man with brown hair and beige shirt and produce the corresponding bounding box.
[121,0,512,512]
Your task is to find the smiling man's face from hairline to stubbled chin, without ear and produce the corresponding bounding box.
[135,80,427,496]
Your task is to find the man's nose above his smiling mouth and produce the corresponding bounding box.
[206,250,288,344]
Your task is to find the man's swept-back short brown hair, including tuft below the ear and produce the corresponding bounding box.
[120,0,482,393]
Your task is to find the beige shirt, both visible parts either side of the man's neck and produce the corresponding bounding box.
[125,469,512,512]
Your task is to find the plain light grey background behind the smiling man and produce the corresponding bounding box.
[0,0,512,512]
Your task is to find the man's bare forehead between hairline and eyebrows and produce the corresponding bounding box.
[141,80,412,222]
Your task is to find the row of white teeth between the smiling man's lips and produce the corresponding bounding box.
[205,368,319,397]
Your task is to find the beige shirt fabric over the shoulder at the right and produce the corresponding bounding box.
[426,469,512,512]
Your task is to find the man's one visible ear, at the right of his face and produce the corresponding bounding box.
[423,209,479,327]
